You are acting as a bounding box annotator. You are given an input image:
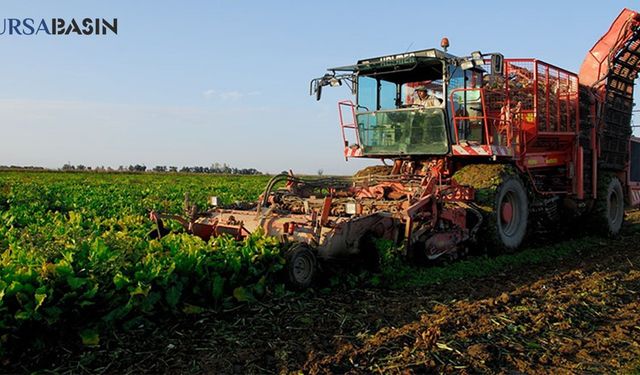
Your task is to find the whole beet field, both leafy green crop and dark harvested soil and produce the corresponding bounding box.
[0,172,640,373]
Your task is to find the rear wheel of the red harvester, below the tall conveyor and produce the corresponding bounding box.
[595,174,624,237]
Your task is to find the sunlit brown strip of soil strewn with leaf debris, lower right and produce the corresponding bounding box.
[303,259,640,373]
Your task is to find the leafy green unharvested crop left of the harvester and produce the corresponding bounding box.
[0,172,283,352]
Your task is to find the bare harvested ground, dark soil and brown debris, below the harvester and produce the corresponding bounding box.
[10,212,640,374]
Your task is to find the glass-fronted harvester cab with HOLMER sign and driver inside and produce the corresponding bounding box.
[310,45,511,160]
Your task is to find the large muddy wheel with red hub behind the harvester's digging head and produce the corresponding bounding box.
[493,176,529,251]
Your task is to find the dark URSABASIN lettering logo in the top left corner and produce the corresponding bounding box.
[0,18,118,35]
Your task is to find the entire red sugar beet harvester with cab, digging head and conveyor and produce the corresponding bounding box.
[151,9,640,287]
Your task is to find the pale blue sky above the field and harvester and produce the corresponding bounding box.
[0,0,640,174]
